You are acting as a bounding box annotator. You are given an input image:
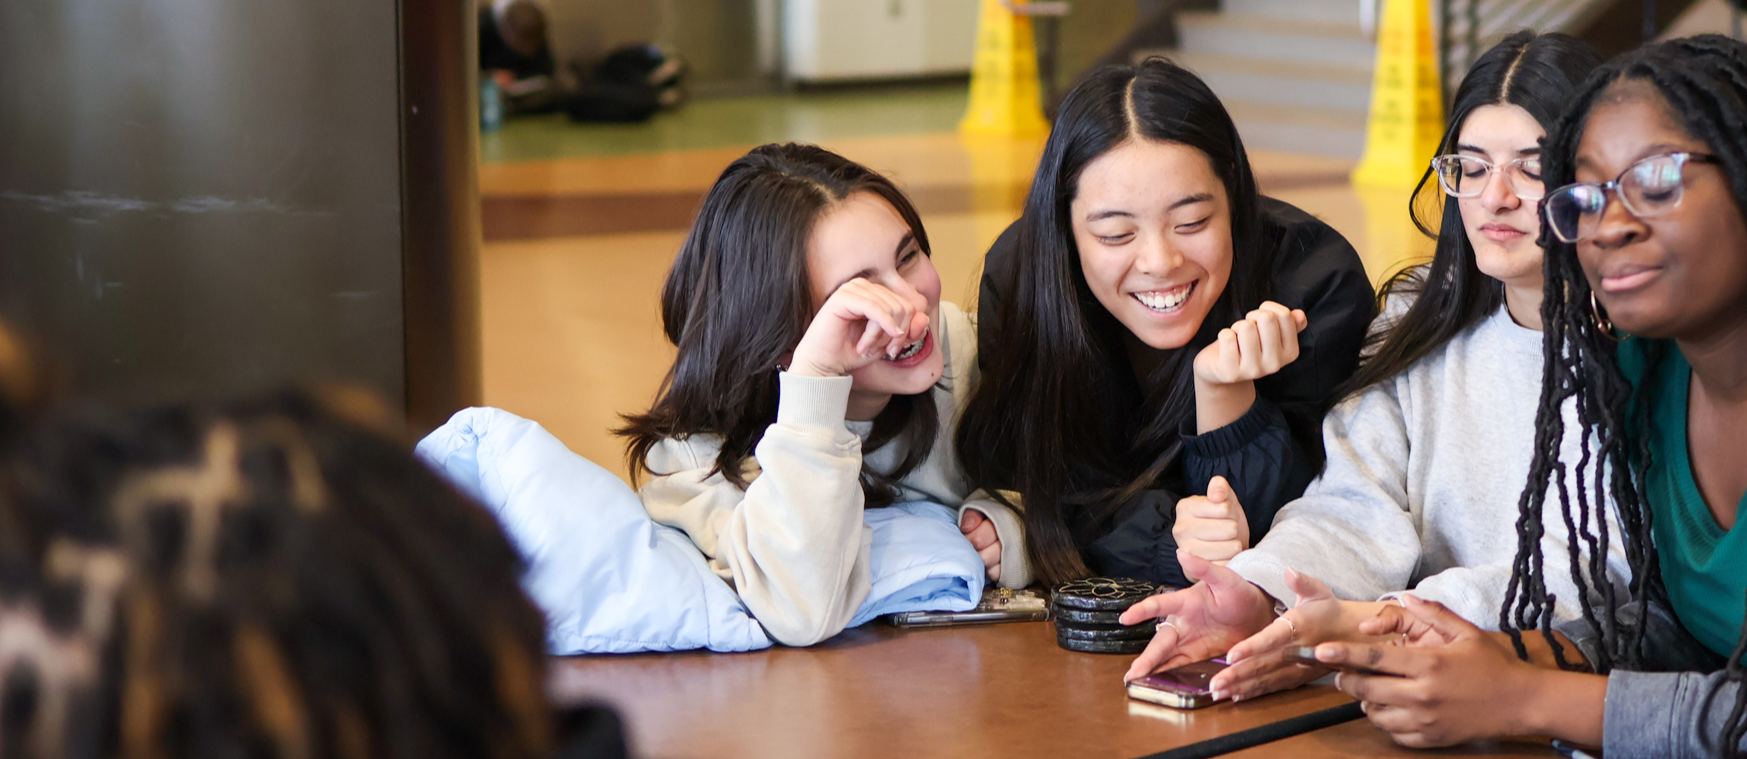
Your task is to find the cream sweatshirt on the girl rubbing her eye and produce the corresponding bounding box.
[638,303,1031,645]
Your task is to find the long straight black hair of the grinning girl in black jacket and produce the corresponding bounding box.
[957,58,1275,582]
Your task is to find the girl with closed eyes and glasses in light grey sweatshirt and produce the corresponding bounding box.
[1125,31,1625,698]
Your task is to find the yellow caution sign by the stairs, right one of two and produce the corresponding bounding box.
[1352,0,1443,187]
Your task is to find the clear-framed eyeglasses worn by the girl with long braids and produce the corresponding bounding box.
[1541,152,1717,243]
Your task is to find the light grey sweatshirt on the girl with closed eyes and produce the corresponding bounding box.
[1228,299,1630,630]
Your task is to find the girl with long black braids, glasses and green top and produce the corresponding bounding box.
[1317,35,1747,757]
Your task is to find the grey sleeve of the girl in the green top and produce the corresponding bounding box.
[1602,670,1747,759]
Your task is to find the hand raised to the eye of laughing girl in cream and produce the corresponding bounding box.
[788,276,928,376]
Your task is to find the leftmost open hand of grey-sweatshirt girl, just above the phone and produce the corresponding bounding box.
[1122,549,1274,682]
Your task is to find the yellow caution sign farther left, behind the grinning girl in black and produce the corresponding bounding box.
[959,0,1050,136]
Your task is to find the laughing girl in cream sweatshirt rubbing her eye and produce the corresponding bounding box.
[620,143,1029,645]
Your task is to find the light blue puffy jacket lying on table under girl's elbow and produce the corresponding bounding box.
[418,407,984,656]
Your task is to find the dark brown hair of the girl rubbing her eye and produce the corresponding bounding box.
[615,143,940,505]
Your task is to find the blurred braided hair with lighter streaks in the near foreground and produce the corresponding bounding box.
[0,392,552,759]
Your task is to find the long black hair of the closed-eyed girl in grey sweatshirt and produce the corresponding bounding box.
[1340,30,1602,397]
